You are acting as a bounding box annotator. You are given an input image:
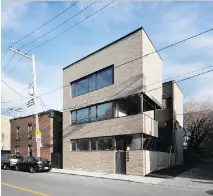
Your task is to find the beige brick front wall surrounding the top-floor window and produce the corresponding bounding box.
[63,31,142,131]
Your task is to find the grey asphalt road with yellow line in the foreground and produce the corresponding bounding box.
[1,170,213,196]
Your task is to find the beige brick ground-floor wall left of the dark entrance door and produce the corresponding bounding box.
[63,151,115,173]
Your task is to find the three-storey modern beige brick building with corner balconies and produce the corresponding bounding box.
[63,28,184,175]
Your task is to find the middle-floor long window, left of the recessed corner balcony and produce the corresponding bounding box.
[71,102,114,125]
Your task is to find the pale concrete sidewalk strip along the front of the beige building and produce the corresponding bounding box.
[51,168,164,184]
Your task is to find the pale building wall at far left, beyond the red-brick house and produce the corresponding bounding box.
[1,116,11,150]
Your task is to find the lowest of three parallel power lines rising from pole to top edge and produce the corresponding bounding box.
[27,1,114,53]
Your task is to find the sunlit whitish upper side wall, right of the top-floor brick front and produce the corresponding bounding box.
[142,31,162,106]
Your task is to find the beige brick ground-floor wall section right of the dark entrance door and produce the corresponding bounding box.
[126,150,143,176]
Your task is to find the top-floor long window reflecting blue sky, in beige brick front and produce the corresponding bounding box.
[71,66,114,97]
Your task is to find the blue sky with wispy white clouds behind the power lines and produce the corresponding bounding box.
[1,1,213,114]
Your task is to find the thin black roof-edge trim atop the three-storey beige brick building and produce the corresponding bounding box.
[63,27,162,70]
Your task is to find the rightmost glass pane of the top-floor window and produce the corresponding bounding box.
[97,68,113,88]
